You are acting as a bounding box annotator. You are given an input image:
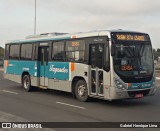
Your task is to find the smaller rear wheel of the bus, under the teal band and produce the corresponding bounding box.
[22,75,31,92]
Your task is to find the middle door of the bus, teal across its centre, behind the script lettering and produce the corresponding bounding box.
[39,46,49,86]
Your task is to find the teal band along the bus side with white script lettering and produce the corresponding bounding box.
[6,60,70,80]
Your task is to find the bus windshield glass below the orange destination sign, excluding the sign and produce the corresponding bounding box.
[113,41,154,77]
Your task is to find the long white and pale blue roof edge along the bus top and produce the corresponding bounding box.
[6,29,146,44]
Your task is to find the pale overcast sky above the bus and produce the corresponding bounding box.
[0,0,160,49]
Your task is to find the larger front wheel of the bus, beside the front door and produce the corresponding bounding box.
[75,80,88,102]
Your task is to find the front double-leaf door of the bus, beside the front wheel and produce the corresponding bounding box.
[89,43,104,96]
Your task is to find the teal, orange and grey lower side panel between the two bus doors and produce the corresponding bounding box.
[48,62,89,92]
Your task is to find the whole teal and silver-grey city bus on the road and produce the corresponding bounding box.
[4,29,156,101]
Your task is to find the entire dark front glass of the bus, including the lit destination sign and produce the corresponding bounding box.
[111,31,154,83]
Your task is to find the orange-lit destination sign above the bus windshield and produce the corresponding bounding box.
[112,33,150,41]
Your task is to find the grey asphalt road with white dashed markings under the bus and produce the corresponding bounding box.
[0,71,160,131]
